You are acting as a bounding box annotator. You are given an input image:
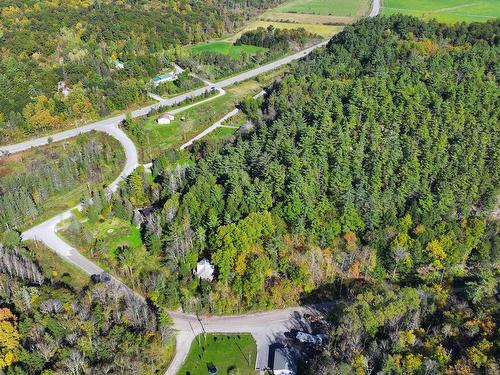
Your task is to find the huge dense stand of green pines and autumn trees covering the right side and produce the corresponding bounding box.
[62,16,500,374]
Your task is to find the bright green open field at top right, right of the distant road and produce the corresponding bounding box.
[382,0,500,23]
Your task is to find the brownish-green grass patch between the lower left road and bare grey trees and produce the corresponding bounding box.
[25,241,90,291]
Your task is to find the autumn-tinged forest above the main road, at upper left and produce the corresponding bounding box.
[0,0,286,143]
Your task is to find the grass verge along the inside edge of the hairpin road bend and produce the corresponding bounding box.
[0,132,125,230]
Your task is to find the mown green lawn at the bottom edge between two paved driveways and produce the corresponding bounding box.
[177,334,257,375]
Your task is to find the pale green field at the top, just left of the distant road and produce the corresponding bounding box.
[274,0,368,17]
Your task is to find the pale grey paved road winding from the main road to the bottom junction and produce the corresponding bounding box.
[0,0,380,375]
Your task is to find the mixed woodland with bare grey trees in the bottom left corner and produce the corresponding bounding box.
[0,245,173,375]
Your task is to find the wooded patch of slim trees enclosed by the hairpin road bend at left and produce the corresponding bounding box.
[0,133,124,231]
